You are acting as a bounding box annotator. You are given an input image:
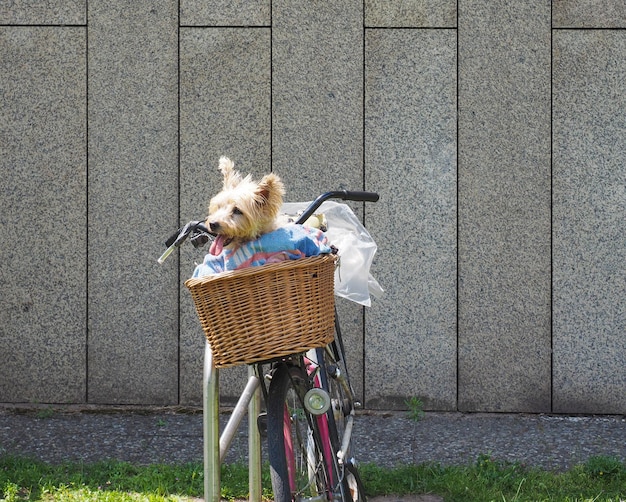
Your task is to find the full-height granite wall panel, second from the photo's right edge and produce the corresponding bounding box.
[458,0,551,412]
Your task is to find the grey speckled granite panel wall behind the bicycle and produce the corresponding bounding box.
[0,0,626,413]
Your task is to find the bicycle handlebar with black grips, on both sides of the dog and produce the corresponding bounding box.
[157,190,379,264]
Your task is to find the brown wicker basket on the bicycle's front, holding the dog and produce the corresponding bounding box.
[185,255,336,368]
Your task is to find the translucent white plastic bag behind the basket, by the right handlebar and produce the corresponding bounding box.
[281,201,384,307]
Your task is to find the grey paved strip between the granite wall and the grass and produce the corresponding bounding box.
[0,408,626,469]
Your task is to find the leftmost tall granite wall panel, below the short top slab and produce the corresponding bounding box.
[0,26,87,403]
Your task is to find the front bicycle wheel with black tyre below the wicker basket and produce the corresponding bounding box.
[267,364,332,502]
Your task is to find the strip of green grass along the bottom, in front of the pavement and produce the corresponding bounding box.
[0,456,626,502]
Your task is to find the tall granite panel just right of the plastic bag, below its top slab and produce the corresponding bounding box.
[365,30,457,410]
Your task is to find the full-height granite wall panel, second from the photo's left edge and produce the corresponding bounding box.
[87,0,179,404]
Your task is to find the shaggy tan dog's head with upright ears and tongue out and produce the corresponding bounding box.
[207,157,285,254]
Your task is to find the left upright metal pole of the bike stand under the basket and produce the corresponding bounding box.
[202,342,221,502]
